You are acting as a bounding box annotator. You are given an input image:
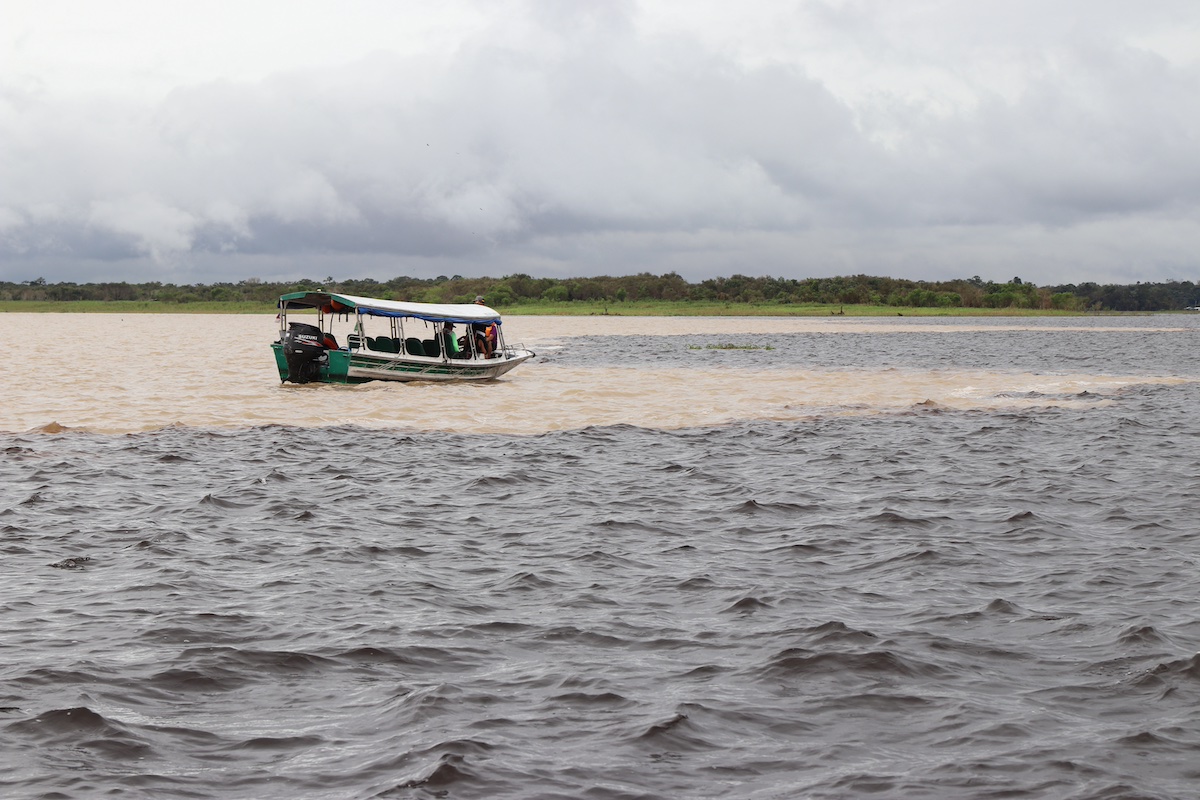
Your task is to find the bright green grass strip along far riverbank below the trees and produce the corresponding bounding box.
[0,300,1108,317]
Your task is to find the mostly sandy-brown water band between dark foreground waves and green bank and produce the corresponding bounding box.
[0,314,1196,433]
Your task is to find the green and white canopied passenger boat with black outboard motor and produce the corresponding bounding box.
[271,291,535,384]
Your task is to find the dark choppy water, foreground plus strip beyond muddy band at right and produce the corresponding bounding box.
[0,321,1200,800]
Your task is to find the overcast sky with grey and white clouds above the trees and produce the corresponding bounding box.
[0,0,1200,285]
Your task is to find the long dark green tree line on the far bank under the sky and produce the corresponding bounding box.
[0,272,1200,311]
